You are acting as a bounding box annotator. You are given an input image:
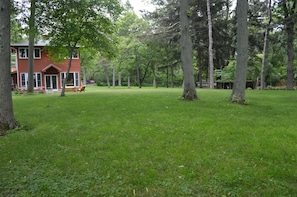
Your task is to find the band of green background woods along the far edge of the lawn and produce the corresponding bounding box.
[11,0,297,89]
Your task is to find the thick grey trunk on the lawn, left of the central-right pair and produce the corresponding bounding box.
[179,0,198,100]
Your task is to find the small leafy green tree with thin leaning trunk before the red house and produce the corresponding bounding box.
[43,0,122,96]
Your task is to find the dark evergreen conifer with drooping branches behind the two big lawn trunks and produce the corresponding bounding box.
[150,0,235,86]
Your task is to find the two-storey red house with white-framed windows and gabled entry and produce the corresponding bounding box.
[11,41,81,92]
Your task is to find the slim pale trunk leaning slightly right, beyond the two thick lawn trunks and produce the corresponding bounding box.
[256,0,272,90]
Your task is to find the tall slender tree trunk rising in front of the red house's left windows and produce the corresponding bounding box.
[27,0,35,93]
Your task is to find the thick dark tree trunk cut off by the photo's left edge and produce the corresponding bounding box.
[0,0,18,136]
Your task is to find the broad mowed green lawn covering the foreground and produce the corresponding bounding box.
[0,87,297,197]
